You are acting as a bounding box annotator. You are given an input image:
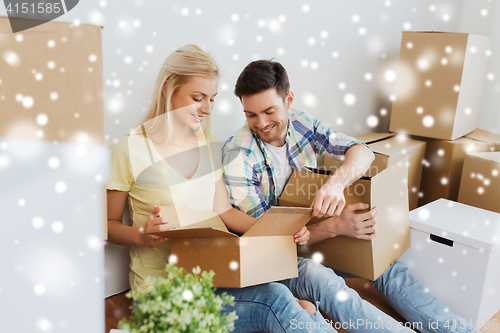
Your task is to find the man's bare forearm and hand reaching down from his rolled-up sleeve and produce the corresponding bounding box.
[311,144,375,217]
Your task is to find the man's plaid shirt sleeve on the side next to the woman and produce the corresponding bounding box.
[222,143,270,218]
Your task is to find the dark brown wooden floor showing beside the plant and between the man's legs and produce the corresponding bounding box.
[105,279,500,333]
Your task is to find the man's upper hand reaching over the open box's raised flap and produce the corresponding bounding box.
[310,178,345,217]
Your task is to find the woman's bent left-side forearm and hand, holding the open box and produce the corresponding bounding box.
[107,190,175,247]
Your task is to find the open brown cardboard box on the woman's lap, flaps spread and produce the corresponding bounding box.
[148,206,311,288]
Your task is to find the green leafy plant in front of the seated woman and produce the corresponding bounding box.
[118,264,238,333]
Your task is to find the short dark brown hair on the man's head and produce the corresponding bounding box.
[234,59,290,100]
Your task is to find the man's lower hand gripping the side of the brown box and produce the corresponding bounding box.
[331,203,380,240]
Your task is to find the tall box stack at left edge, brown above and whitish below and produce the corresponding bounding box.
[0,17,109,332]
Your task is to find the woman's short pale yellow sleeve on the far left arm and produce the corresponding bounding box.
[106,140,133,191]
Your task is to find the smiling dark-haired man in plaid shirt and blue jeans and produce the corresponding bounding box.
[222,60,476,332]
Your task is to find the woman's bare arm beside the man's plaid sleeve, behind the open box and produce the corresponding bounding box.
[214,177,257,234]
